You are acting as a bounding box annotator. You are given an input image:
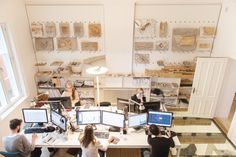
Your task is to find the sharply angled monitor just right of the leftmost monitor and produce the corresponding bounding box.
[51,110,67,131]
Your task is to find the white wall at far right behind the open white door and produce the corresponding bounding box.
[212,0,236,144]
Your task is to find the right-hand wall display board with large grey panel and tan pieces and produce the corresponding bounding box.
[133,2,221,77]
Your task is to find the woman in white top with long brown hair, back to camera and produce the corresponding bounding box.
[80,125,112,157]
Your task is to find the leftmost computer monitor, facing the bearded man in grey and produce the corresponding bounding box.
[22,108,48,123]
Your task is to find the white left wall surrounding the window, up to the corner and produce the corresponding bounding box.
[0,0,36,149]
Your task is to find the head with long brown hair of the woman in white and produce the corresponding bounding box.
[81,125,95,148]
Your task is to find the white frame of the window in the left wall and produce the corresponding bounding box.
[0,23,26,114]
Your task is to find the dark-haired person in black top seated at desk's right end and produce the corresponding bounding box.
[147,124,175,157]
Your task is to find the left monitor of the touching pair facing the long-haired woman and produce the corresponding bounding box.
[76,110,101,125]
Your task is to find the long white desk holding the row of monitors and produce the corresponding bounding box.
[26,107,181,156]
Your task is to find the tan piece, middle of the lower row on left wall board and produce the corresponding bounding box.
[57,37,77,51]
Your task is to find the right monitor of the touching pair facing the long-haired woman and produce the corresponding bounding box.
[102,111,125,128]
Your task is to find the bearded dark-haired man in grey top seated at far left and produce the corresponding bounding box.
[3,119,41,157]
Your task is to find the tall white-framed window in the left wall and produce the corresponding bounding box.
[0,24,23,113]
